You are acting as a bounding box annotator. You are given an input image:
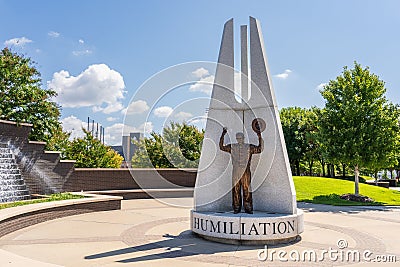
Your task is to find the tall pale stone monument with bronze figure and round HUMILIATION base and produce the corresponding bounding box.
[191,17,303,244]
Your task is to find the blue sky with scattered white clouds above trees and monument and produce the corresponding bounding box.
[0,0,400,145]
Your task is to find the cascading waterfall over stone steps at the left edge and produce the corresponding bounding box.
[0,143,30,202]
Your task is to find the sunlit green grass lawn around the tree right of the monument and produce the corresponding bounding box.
[293,176,400,206]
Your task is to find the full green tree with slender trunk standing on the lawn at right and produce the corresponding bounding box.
[320,62,399,195]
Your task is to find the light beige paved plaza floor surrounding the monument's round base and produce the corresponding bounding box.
[0,198,400,266]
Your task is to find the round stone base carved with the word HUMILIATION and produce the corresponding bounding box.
[191,209,304,245]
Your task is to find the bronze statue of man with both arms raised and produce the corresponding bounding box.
[219,124,264,214]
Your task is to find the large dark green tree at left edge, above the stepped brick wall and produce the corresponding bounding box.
[0,48,61,141]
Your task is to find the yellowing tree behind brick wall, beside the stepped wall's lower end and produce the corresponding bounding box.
[64,128,123,168]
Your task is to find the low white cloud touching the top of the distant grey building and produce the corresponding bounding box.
[104,121,153,145]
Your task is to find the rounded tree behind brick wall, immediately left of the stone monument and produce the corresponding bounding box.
[132,122,204,168]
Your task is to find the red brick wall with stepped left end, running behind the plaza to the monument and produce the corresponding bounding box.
[0,120,196,194]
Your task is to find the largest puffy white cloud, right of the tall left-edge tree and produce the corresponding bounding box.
[47,64,125,114]
